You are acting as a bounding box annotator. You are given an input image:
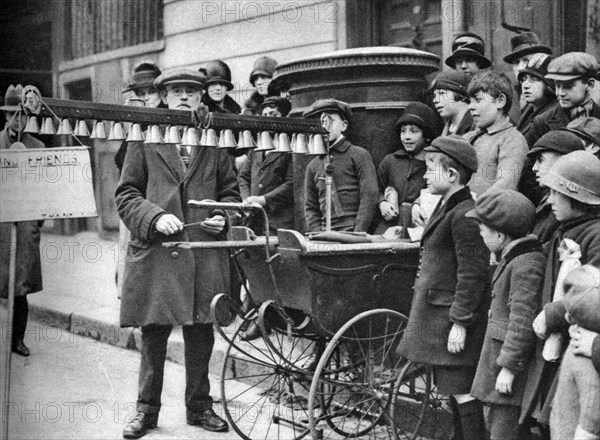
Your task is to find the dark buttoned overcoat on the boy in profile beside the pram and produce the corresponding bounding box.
[399,187,490,367]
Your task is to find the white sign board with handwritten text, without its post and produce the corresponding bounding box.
[0,147,98,222]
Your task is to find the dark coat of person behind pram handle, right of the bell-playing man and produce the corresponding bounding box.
[239,151,294,235]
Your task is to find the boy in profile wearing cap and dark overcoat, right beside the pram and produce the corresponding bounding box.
[399,135,490,440]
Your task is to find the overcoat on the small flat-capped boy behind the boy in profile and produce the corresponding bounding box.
[471,235,546,406]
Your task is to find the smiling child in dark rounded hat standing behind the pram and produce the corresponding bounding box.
[375,102,439,233]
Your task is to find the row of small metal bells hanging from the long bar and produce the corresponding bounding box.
[24,116,327,155]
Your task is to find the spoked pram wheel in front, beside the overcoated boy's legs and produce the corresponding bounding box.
[308,309,407,439]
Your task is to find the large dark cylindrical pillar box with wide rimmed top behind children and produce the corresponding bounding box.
[275,47,440,231]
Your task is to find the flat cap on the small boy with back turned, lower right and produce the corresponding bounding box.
[465,189,535,238]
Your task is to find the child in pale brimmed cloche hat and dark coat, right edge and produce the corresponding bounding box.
[520,151,600,434]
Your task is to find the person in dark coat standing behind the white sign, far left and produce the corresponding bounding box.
[0,84,45,356]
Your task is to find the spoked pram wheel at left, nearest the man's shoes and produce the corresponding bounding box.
[221,310,322,440]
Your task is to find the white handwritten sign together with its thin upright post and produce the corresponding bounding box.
[0,147,98,439]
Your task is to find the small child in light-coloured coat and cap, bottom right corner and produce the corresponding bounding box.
[550,264,600,439]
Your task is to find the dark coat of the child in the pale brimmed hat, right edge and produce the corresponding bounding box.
[520,215,600,424]
